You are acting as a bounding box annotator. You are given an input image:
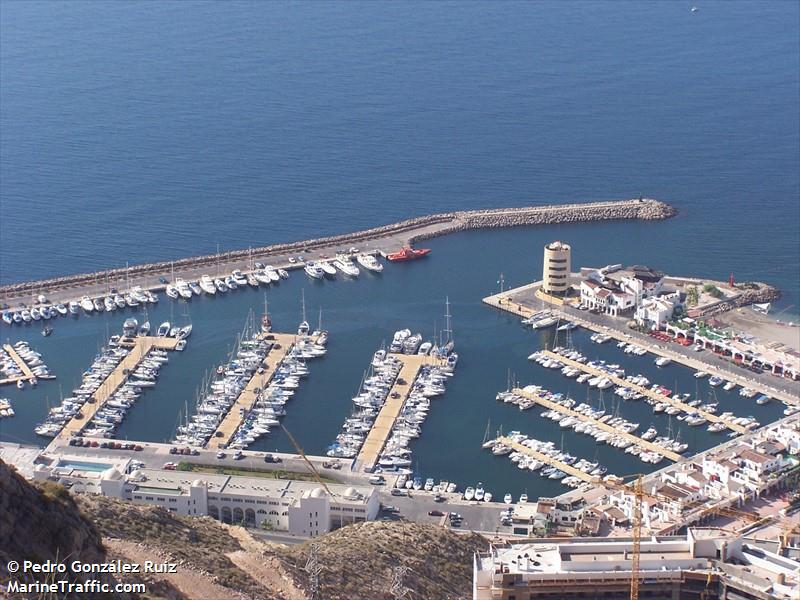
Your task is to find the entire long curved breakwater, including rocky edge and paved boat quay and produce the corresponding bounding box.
[0,198,677,310]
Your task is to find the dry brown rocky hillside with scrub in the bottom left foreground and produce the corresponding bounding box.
[0,461,486,600]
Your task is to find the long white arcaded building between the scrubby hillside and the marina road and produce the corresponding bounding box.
[34,458,380,537]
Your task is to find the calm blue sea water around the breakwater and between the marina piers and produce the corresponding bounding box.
[0,0,800,493]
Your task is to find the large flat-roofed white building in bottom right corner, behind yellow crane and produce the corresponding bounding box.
[472,528,800,600]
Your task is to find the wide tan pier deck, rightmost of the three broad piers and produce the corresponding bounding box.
[355,354,444,470]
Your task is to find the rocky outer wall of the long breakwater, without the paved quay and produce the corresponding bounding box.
[0,198,677,297]
